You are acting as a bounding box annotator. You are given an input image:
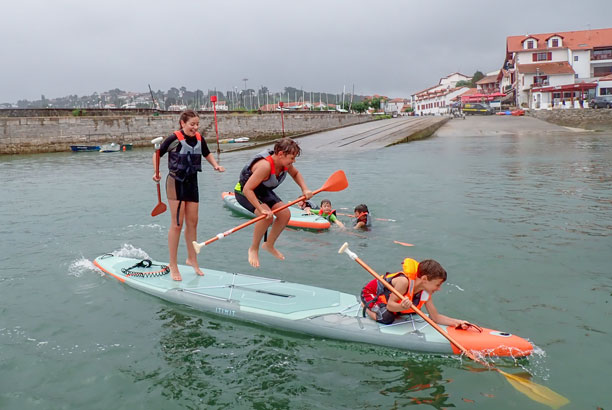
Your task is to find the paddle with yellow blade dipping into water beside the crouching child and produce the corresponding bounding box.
[338,242,569,409]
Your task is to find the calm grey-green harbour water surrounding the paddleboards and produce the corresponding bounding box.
[0,126,612,409]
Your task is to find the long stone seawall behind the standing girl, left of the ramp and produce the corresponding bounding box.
[0,110,373,154]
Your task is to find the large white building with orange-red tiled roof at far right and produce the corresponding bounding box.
[504,28,612,109]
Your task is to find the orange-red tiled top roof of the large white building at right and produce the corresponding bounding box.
[506,28,612,53]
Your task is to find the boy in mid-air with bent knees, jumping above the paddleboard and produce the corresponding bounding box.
[234,138,312,268]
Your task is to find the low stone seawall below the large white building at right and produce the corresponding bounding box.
[526,108,612,131]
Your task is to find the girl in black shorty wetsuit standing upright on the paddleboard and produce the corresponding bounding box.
[153,110,225,280]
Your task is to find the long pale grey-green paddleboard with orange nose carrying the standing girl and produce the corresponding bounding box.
[94,254,533,357]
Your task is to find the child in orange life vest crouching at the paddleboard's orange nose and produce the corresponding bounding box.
[361,258,476,329]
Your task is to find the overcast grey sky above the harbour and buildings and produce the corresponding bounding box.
[0,0,612,103]
